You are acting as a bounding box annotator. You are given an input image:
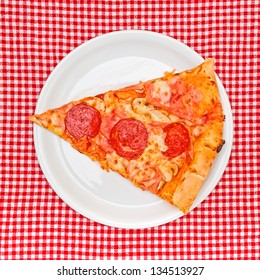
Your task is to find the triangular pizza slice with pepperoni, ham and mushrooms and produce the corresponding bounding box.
[30,59,224,213]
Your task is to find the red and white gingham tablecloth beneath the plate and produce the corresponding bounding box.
[0,0,260,259]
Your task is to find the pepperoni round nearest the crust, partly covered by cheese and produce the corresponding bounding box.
[162,123,190,158]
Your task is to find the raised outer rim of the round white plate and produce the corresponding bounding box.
[33,30,234,229]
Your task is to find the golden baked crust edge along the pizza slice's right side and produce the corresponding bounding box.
[160,59,224,213]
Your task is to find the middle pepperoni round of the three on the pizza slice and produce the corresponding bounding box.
[110,118,148,159]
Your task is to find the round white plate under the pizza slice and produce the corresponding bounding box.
[34,30,233,228]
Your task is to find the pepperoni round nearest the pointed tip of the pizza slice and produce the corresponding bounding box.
[65,103,101,140]
